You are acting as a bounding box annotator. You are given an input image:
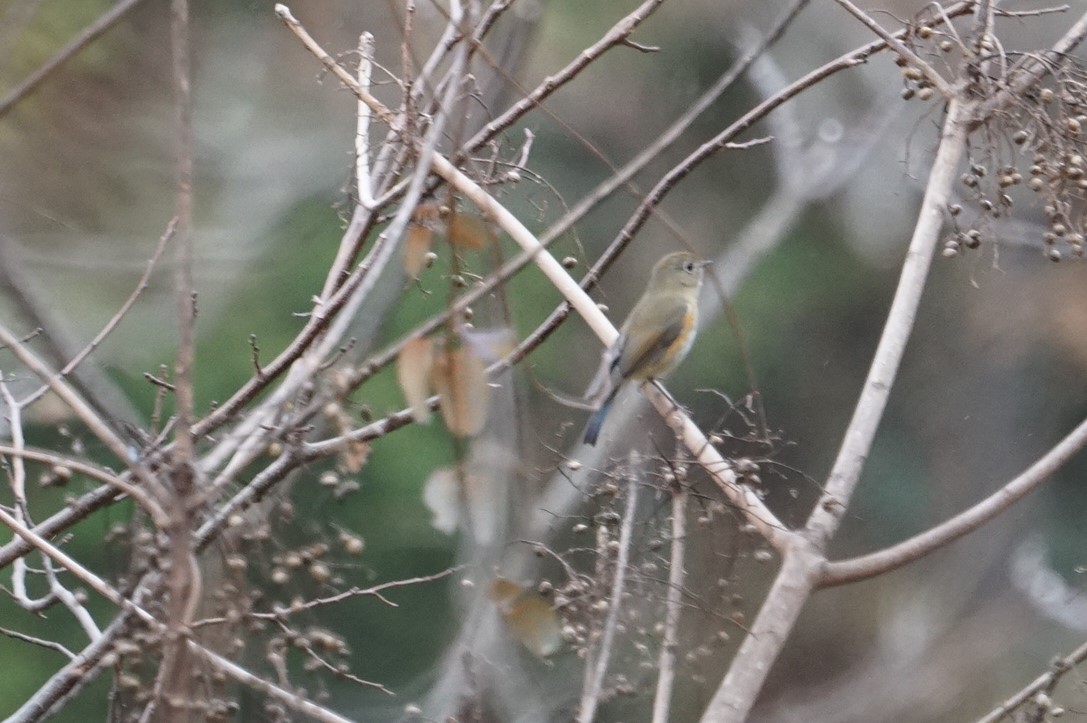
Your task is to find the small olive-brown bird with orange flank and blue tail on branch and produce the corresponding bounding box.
[585,251,712,445]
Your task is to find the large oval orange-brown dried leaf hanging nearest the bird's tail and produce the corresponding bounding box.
[430,346,490,437]
